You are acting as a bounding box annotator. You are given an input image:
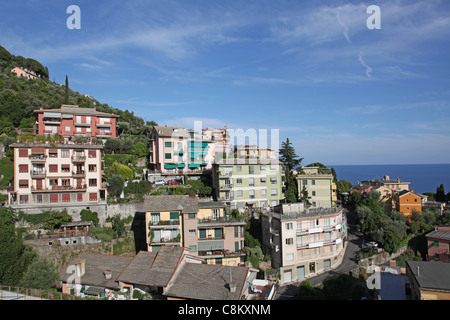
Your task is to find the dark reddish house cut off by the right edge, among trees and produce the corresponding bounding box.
[426,226,450,262]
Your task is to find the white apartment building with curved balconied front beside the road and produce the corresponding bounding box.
[261,203,347,283]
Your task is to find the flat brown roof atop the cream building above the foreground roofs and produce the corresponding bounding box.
[143,195,198,213]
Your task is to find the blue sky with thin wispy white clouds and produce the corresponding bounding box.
[0,0,450,164]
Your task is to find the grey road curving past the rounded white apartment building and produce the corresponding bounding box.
[275,208,363,300]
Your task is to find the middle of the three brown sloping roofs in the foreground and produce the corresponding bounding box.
[117,246,185,287]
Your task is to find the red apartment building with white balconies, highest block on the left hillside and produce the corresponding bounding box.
[34,105,119,141]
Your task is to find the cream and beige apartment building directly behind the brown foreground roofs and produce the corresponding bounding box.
[144,195,245,265]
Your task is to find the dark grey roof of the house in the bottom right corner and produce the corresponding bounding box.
[406,261,450,291]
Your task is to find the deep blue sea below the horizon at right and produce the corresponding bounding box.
[327,164,450,194]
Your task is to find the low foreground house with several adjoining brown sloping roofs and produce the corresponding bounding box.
[60,246,268,300]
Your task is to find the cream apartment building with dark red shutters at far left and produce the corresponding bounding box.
[9,143,106,207]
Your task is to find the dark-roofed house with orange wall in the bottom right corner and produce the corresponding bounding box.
[406,261,450,300]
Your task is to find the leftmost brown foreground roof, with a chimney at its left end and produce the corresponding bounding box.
[59,252,133,290]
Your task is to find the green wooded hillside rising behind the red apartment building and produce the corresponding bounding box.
[0,45,154,136]
